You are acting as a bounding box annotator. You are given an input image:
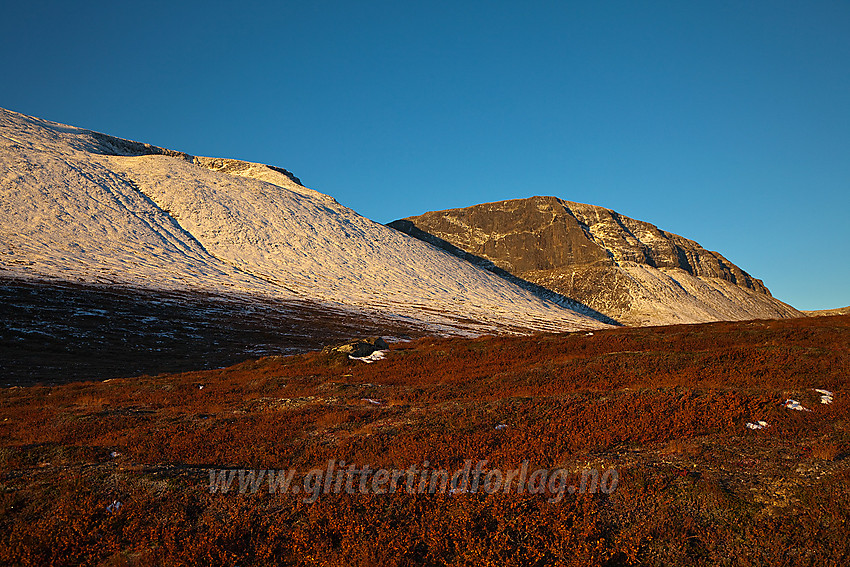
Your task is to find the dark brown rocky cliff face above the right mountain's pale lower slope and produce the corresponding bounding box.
[390,197,769,293]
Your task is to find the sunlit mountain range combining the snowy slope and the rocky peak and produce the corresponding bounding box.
[0,109,802,348]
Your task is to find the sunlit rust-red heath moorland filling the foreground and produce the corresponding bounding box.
[0,316,850,566]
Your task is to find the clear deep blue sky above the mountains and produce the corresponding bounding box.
[0,0,850,309]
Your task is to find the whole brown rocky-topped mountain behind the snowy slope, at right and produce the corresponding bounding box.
[389,197,803,325]
